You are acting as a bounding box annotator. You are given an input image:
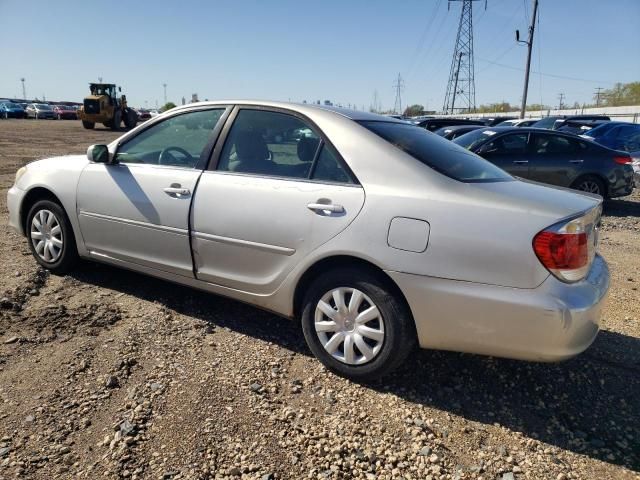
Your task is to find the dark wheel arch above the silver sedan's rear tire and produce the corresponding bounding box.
[293,255,411,320]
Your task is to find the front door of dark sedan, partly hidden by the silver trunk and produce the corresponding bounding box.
[479,132,529,178]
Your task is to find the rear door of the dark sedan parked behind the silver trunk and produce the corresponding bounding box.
[529,133,589,187]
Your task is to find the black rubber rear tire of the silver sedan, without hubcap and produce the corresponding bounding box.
[301,267,417,382]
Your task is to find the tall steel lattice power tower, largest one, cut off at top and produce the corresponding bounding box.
[442,0,487,114]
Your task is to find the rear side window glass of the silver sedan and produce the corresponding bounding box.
[218,109,353,183]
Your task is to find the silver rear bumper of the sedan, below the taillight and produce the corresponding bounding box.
[387,256,609,361]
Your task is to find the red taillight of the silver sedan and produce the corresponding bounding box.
[533,231,589,270]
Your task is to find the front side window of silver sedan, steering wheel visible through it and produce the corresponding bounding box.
[116,108,224,168]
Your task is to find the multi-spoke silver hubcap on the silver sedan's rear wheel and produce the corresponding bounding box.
[314,287,384,365]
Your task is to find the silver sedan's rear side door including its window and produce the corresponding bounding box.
[192,107,364,294]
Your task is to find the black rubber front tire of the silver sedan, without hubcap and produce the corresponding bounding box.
[25,200,79,274]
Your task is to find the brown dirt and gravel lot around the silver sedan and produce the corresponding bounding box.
[0,120,640,480]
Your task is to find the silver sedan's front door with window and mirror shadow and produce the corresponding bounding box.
[77,108,225,276]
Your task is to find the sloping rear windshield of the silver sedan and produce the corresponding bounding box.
[359,121,513,183]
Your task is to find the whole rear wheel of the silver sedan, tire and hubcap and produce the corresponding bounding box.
[302,268,416,381]
